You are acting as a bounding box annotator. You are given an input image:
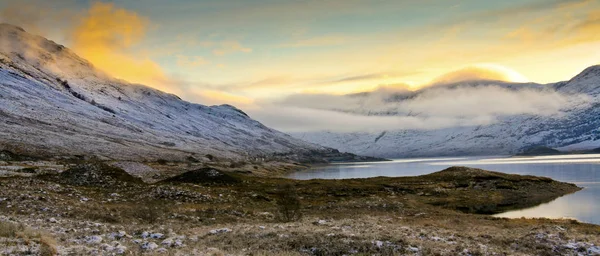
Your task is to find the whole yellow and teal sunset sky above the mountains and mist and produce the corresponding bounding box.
[0,0,600,132]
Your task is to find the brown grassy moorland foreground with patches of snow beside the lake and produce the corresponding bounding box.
[0,163,600,255]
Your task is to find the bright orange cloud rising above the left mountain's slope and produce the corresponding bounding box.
[70,2,177,92]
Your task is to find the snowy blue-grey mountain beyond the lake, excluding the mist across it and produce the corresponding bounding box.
[292,66,600,158]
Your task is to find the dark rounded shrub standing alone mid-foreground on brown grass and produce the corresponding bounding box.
[276,184,302,222]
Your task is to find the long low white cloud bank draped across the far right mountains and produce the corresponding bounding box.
[249,67,591,132]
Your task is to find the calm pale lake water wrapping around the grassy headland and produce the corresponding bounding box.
[288,154,600,225]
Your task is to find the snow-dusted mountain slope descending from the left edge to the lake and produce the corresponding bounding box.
[0,24,380,162]
